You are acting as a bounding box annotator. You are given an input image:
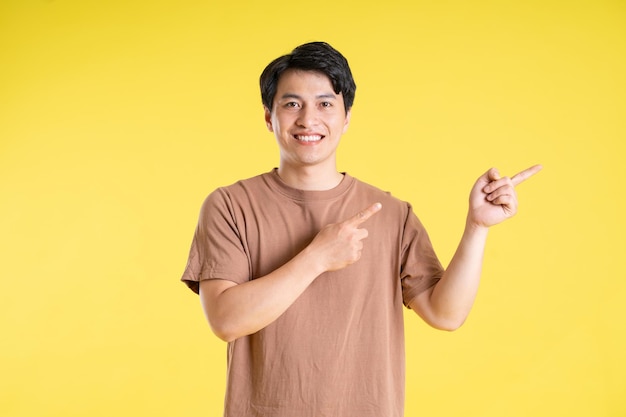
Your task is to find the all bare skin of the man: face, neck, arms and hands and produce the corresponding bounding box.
[200,70,541,341]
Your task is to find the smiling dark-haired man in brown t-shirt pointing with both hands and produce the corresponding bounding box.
[182,42,541,417]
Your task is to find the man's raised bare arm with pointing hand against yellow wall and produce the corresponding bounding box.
[410,165,542,330]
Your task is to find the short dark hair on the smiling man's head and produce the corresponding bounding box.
[259,42,356,113]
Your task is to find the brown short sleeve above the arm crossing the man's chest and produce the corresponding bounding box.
[181,188,250,293]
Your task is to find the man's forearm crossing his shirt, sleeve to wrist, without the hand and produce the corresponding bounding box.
[200,245,323,341]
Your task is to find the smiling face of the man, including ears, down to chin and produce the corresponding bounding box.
[265,70,350,170]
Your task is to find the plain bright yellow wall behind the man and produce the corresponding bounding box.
[0,0,626,417]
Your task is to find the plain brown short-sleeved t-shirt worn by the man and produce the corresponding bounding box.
[182,170,443,417]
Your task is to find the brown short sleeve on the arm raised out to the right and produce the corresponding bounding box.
[400,205,444,307]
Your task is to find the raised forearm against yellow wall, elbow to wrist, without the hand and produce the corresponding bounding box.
[422,222,488,330]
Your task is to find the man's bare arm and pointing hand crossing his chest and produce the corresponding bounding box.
[200,203,381,341]
